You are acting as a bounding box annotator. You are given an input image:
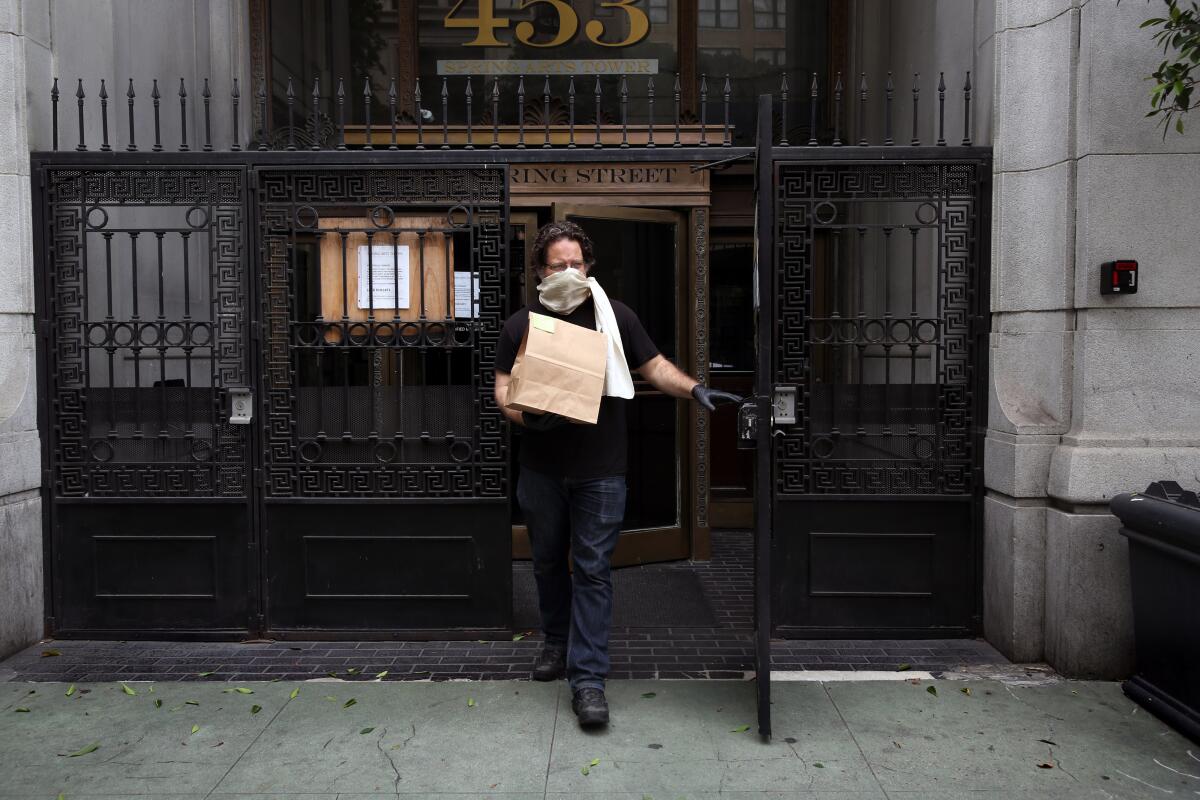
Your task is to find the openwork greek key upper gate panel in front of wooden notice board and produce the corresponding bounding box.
[257,167,508,498]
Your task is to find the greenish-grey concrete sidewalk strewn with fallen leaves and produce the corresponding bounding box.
[0,679,1200,800]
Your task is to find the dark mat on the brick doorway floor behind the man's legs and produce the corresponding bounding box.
[512,564,716,630]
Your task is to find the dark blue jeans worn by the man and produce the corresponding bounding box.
[517,468,625,692]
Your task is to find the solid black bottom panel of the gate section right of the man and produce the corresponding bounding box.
[772,498,978,638]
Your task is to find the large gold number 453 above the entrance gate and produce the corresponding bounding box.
[442,0,650,47]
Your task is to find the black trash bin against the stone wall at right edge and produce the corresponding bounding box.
[1110,481,1200,742]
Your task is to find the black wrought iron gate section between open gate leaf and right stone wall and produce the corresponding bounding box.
[757,97,991,638]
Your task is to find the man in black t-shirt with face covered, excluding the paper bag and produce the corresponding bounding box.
[496,222,740,726]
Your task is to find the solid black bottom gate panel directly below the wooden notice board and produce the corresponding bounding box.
[265,501,512,638]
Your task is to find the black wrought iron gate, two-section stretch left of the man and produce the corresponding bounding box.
[34,160,511,637]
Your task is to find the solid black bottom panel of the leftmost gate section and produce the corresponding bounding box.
[53,500,250,638]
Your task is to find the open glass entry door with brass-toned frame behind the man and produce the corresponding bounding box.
[514,205,691,566]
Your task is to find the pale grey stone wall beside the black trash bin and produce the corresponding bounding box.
[984,0,1200,678]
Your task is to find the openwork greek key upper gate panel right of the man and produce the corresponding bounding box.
[773,162,982,495]
